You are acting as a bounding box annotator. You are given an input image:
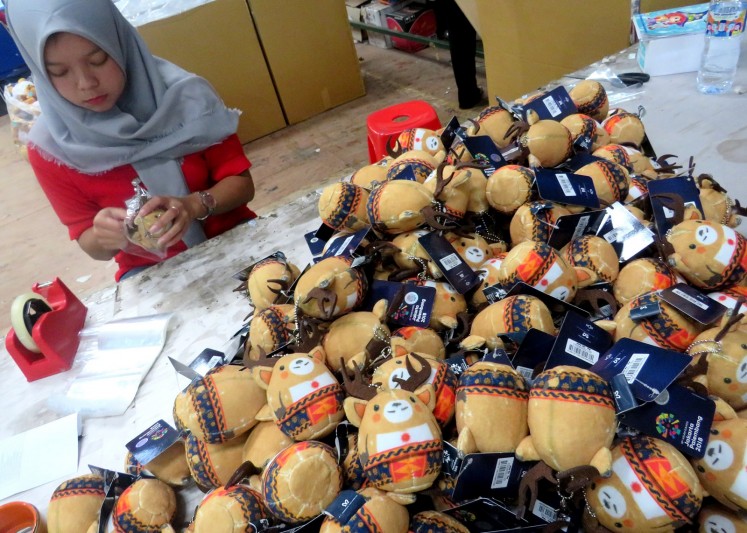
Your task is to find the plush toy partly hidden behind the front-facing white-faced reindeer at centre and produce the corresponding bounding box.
[371,352,457,428]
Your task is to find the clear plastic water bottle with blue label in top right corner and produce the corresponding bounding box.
[698,0,745,94]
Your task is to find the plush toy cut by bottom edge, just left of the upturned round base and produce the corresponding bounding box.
[192,484,269,533]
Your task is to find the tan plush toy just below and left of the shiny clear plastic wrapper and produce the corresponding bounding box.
[560,235,620,289]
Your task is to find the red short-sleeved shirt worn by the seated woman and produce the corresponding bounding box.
[28,135,257,281]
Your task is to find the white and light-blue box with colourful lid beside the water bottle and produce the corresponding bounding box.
[633,3,708,76]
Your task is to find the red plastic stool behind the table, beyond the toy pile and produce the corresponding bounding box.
[366,100,441,163]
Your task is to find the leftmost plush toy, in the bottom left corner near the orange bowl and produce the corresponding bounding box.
[47,474,106,533]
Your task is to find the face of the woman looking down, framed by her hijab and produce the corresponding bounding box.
[44,33,125,112]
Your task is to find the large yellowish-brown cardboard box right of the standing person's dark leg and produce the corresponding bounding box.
[457,0,630,102]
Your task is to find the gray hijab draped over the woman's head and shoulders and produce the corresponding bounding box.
[5,0,239,246]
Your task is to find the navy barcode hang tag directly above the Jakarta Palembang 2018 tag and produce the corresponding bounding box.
[591,338,692,402]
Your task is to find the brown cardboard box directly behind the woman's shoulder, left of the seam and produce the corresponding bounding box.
[138,0,286,143]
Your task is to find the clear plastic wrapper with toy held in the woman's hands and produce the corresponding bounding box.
[124,179,171,261]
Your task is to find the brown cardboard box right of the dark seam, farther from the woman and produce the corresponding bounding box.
[248,0,366,124]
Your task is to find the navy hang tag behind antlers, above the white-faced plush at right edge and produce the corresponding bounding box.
[648,176,703,239]
